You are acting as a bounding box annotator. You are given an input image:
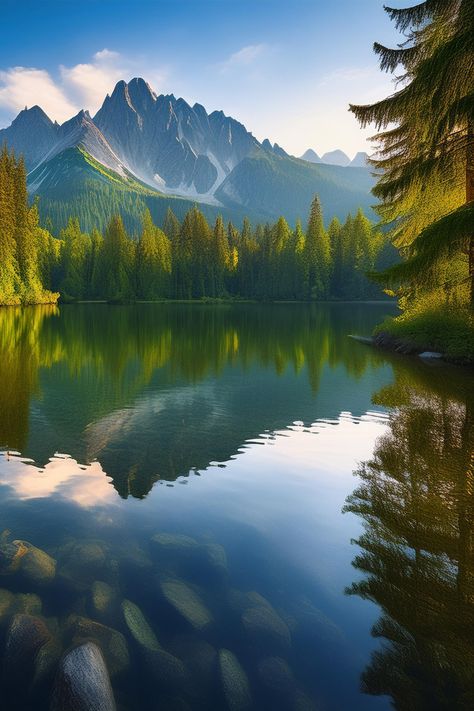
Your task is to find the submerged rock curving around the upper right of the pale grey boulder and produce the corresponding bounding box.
[66,615,130,676]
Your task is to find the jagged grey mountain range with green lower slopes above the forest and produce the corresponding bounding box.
[0,78,373,234]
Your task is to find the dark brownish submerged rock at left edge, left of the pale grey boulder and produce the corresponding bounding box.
[3,614,51,686]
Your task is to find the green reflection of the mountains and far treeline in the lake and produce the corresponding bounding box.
[0,304,388,498]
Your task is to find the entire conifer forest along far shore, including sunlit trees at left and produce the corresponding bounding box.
[0,148,395,305]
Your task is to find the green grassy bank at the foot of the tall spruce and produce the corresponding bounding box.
[374,306,474,364]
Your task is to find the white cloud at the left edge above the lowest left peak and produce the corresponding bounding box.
[0,67,77,121]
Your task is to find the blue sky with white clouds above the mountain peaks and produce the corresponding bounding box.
[0,0,413,157]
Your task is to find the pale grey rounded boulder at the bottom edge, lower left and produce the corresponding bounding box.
[51,642,116,711]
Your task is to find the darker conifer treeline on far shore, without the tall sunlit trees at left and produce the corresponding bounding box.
[51,198,390,301]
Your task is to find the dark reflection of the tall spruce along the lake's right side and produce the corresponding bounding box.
[345,366,474,711]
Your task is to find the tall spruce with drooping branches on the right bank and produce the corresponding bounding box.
[351,0,474,309]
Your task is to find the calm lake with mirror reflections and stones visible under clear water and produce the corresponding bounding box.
[0,303,474,711]
